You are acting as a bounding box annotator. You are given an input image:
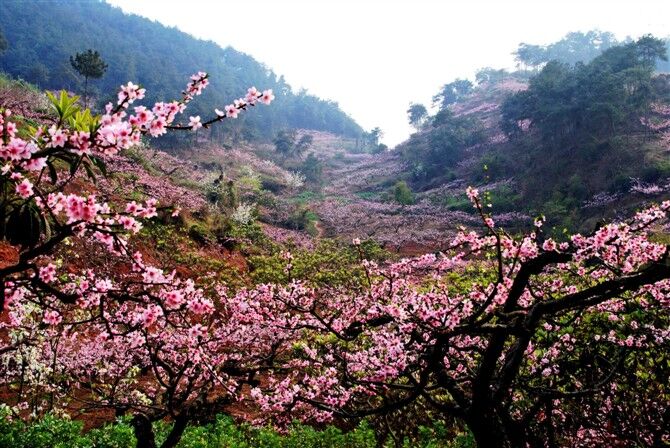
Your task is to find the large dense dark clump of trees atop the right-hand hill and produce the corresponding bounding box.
[502,36,667,148]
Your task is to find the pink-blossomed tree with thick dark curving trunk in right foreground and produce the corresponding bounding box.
[245,189,670,447]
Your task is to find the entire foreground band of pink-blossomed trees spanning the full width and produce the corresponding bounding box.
[0,73,670,447]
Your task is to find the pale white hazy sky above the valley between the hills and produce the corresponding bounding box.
[108,0,670,146]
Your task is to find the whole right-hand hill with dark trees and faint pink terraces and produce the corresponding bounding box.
[398,32,670,229]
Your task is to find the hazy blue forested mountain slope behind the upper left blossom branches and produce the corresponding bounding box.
[0,0,362,140]
